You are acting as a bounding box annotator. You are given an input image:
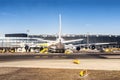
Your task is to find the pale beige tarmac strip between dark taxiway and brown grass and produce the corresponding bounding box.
[0,52,120,70]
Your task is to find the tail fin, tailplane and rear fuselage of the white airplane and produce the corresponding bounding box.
[40,14,83,53]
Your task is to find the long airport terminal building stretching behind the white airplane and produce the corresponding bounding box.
[0,33,120,48]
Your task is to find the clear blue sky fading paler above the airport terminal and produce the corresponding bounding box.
[0,0,120,35]
